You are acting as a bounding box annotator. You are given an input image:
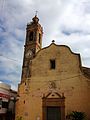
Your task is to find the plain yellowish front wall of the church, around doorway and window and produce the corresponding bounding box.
[16,43,90,120]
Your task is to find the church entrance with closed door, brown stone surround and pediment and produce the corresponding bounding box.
[42,92,65,120]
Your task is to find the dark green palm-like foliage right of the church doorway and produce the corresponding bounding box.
[67,111,86,120]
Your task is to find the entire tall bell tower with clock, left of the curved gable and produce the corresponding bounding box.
[21,15,43,82]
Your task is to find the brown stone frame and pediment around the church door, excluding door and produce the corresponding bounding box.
[42,93,65,120]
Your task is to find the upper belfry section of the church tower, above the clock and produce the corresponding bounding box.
[25,15,43,55]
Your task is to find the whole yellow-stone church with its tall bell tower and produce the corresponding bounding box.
[15,15,90,120]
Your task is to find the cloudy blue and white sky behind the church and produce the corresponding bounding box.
[0,0,90,90]
